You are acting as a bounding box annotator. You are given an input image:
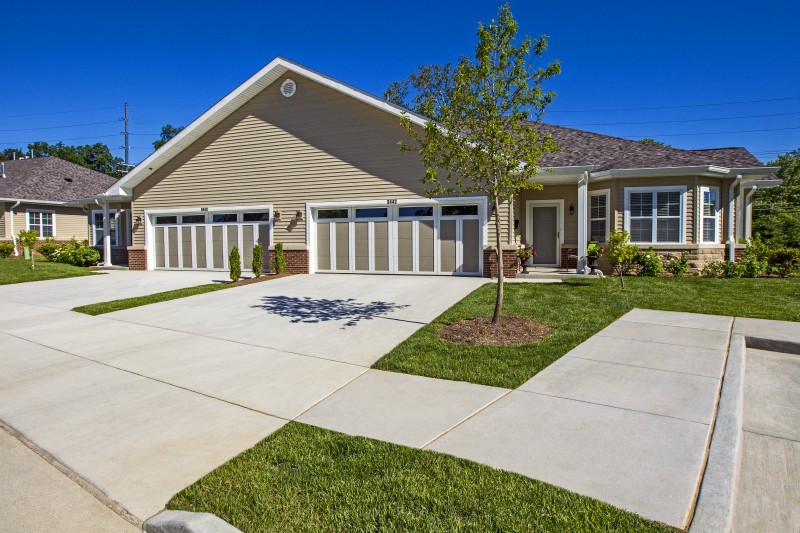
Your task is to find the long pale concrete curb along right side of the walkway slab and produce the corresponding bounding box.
[689,334,747,533]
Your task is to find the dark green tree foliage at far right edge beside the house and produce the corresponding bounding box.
[753,149,800,248]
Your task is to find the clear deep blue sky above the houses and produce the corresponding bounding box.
[0,0,800,163]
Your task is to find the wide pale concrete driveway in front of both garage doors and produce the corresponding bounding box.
[0,272,484,520]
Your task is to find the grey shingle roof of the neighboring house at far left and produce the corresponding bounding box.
[0,156,117,202]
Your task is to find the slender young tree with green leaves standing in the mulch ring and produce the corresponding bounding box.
[386,4,561,325]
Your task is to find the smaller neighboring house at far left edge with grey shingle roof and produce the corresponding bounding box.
[0,157,128,260]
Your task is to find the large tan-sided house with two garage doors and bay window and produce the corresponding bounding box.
[73,58,777,276]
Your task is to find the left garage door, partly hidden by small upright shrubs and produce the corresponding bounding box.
[150,208,270,271]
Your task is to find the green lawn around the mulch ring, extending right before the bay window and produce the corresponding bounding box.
[374,278,800,388]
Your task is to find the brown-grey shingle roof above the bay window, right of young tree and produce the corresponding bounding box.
[531,122,765,172]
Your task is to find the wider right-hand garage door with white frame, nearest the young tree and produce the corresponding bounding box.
[312,203,483,275]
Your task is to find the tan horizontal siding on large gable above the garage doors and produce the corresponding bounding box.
[133,73,468,245]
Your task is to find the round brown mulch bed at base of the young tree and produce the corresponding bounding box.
[437,316,553,346]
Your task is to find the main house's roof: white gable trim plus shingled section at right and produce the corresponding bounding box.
[105,57,771,199]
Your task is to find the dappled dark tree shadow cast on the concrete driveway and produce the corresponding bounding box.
[253,296,409,329]
